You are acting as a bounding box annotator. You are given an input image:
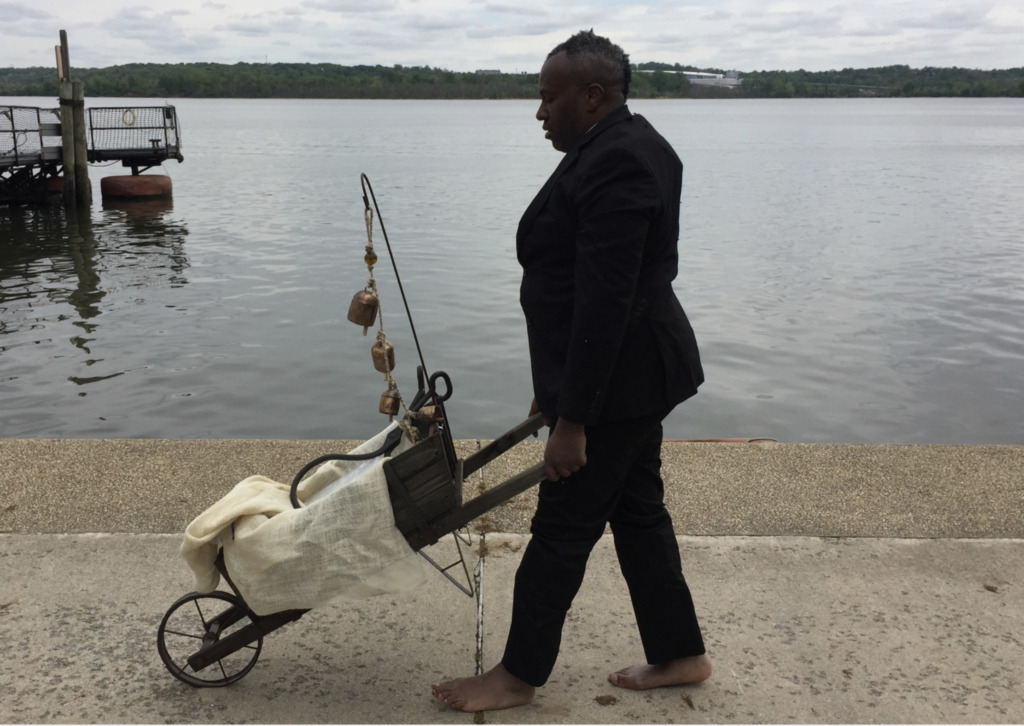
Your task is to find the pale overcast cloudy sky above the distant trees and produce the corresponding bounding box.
[0,0,1024,73]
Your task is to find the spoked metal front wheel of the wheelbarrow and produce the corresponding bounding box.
[157,591,263,688]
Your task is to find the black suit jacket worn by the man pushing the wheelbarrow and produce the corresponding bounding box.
[516,105,703,425]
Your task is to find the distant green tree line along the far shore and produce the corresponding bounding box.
[0,62,1024,98]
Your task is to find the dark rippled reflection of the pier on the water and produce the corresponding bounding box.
[0,200,188,436]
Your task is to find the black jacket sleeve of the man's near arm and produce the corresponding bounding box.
[558,144,662,424]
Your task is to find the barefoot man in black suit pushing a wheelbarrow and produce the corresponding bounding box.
[433,31,711,712]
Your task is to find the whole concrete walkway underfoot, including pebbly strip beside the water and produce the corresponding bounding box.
[0,439,1024,723]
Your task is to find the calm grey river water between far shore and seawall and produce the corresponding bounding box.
[0,98,1024,444]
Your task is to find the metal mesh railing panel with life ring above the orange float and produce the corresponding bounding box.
[88,105,180,156]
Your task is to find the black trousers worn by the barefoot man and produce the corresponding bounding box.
[502,416,705,686]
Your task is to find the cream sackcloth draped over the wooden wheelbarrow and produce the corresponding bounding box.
[181,424,425,615]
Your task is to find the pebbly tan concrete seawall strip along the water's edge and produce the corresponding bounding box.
[0,439,1024,538]
